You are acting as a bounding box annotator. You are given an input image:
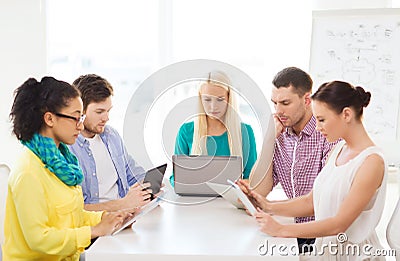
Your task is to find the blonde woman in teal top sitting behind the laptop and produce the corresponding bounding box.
[170,72,257,185]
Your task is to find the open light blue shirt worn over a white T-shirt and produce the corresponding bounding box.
[69,126,146,204]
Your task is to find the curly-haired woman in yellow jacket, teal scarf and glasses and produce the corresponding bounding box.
[3,77,131,261]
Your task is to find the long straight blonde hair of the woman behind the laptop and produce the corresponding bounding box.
[191,71,243,158]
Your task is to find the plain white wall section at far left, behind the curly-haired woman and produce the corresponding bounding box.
[0,0,47,165]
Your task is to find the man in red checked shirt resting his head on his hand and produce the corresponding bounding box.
[250,67,335,250]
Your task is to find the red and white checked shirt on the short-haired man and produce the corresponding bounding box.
[273,116,336,223]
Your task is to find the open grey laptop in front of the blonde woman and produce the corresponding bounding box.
[172,155,242,196]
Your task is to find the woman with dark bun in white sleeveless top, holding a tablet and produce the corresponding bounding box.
[241,81,387,260]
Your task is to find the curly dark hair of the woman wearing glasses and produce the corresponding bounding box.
[10,77,80,141]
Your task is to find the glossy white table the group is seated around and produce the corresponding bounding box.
[86,190,298,261]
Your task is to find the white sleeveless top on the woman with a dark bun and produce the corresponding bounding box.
[313,141,387,260]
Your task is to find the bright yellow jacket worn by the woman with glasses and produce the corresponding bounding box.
[3,148,102,261]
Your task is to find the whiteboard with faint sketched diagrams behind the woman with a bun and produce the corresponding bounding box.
[310,8,400,140]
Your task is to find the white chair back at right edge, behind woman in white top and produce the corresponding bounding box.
[386,195,400,260]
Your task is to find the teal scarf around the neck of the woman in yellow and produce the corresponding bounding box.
[21,133,83,186]
